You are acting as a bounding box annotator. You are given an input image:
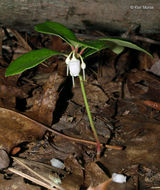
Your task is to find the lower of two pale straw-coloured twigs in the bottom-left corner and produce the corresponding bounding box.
[8,168,57,190]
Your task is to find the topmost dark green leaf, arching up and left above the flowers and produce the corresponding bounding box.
[34,22,77,46]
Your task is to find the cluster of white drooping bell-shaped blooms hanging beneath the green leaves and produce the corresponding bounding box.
[65,51,86,86]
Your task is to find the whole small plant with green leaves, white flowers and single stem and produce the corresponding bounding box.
[5,22,150,158]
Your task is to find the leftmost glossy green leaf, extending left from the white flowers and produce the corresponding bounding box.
[5,48,64,76]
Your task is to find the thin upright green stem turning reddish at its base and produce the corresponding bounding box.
[79,75,100,158]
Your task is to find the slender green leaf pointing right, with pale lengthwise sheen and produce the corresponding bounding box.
[100,38,152,57]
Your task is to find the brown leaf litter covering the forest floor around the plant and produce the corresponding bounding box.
[0,28,160,190]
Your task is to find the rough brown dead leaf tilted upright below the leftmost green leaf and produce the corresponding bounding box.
[27,72,65,126]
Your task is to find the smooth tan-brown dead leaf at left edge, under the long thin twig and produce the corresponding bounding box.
[0,107,45,152]
